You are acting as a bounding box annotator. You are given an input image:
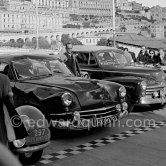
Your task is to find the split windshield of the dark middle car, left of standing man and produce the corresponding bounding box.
[13,58,73,79]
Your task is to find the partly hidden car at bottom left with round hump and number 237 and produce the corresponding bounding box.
[9,105,51,165]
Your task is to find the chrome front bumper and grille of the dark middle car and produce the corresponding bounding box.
[51,107,128,130]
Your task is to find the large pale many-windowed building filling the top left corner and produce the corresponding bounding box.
[0,0,69,32]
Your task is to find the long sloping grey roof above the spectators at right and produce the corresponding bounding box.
[110,34,166,50]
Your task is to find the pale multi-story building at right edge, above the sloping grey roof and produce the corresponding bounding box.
[150,21,166,39]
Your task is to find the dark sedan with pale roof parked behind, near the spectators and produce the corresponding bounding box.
[73,45,166,111]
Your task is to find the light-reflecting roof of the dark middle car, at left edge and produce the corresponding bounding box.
[0,49,58,60]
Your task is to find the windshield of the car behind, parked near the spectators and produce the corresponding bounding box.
[98,51,128,65]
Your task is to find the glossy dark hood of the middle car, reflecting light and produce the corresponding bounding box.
[21,75,111,106]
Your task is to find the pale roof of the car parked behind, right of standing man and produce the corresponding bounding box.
[73,45,118,52]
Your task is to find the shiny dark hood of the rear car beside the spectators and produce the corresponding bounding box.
[103,65,165,82]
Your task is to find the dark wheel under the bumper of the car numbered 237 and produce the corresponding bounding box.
[18,150,43,165]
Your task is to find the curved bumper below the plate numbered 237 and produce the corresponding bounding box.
[15,142,50,153]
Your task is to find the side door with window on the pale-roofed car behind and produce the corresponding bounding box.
[77,52,103,79]
